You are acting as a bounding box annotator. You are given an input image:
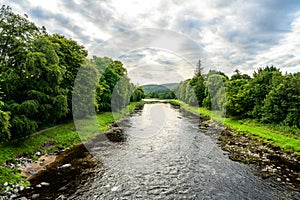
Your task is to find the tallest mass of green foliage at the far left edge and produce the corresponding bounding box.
[0,6,69,142]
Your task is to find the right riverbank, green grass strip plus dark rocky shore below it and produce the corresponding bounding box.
[170,100,300,188]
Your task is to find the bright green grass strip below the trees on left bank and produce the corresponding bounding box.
[0,102,144,189]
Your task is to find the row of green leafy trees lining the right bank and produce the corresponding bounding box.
[174,66,300,128]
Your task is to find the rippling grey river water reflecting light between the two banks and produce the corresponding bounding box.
[22,103,299,200]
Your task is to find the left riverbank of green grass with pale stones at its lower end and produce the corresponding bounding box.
[0,101,144,195]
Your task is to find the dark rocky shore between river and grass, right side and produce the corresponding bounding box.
[218,128,300,189]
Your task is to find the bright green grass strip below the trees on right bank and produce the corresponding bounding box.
[171,100,300,155]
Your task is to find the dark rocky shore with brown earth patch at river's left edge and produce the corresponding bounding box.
[0,126,126,200]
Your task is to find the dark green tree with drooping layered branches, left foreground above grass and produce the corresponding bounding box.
[2,36,68,138]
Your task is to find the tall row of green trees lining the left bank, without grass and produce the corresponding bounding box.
[0,6,143,142]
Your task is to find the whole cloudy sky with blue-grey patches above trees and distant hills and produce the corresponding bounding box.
[3,0,300,84]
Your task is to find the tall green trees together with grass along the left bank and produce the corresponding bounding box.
[0,6,144,194]
